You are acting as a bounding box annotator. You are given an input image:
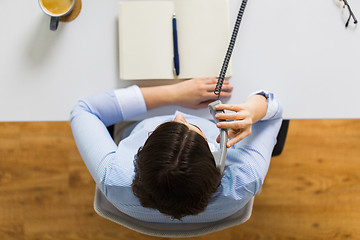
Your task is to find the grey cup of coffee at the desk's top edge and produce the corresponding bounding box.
[39,0,75,31]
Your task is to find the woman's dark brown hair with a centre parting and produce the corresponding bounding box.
[132,122,222,220]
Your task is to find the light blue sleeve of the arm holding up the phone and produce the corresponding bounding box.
[228,90,282,194]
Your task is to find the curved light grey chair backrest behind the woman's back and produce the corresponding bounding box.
[94,188,254,238]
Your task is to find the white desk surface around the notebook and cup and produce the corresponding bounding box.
[0,0,360,121]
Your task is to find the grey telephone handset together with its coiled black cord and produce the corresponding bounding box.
[209,0,247,173]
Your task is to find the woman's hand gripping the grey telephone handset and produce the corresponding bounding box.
[215,95,267,148]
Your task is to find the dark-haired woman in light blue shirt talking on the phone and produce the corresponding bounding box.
[71,78,282,223]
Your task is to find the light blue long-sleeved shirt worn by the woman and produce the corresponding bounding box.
[70,86,282,223]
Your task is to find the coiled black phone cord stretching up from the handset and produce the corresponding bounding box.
[214,0,247,99]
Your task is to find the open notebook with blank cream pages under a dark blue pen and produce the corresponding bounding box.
[119,0,231,80]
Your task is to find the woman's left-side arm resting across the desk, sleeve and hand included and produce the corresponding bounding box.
[70,78,232,184]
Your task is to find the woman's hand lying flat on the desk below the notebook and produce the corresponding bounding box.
[169,78,233,109]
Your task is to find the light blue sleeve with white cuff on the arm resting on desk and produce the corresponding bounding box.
[70,86,147,184]
